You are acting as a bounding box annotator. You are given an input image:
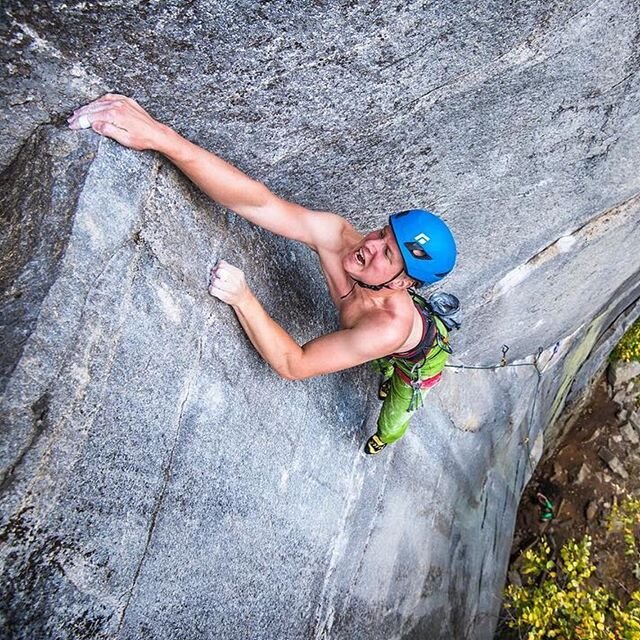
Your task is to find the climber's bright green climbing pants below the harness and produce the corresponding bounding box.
[371,354,448,444]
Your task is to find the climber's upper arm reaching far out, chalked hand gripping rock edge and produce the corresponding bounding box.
[69,94,350,249]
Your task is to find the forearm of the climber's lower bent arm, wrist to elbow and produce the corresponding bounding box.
[232,291,302,380]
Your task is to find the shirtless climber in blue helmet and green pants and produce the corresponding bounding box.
[68,94,456,454]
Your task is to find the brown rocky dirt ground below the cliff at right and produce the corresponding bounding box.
[496,376,640,640]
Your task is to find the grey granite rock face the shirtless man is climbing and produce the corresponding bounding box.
[0,0,640,639]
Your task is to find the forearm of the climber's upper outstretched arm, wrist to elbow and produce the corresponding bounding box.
[154,125,273,219]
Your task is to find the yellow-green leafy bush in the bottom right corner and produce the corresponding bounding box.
[505,536,640,640]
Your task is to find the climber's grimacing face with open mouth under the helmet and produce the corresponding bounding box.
[343,225,404,285]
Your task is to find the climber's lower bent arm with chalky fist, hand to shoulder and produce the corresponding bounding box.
[209,262,411,380]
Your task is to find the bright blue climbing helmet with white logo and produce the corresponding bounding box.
[389,209,456,286]
